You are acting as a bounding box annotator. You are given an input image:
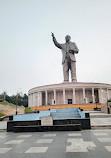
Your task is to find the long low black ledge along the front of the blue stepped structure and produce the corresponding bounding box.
[13,124,81,132]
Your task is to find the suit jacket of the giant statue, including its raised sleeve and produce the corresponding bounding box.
[53,37,79,64]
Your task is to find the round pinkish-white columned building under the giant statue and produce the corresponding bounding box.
[28,82,111,107]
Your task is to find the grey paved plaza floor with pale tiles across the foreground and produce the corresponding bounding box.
[0,130,111,158]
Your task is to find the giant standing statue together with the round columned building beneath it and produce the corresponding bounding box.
[28,33,111,108]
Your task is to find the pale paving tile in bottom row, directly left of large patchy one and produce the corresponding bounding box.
[25,147,48,153]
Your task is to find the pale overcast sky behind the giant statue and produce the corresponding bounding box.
[0,0,111,95]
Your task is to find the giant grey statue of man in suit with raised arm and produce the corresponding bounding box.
[52,33,79,82]
